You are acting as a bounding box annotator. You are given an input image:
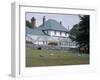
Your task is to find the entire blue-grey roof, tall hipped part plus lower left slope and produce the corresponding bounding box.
[26,19,67,36]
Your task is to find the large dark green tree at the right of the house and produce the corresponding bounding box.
[70,15,90,53]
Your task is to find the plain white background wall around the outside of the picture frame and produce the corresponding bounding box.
[0,0,100,80]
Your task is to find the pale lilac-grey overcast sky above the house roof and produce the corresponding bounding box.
[26,12,80,29]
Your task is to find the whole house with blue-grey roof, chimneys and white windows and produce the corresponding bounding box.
[26,16,77,48]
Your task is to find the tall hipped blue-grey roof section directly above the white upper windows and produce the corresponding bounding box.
[39,19,67,32]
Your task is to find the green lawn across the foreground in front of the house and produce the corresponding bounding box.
[26,48,89,67]
